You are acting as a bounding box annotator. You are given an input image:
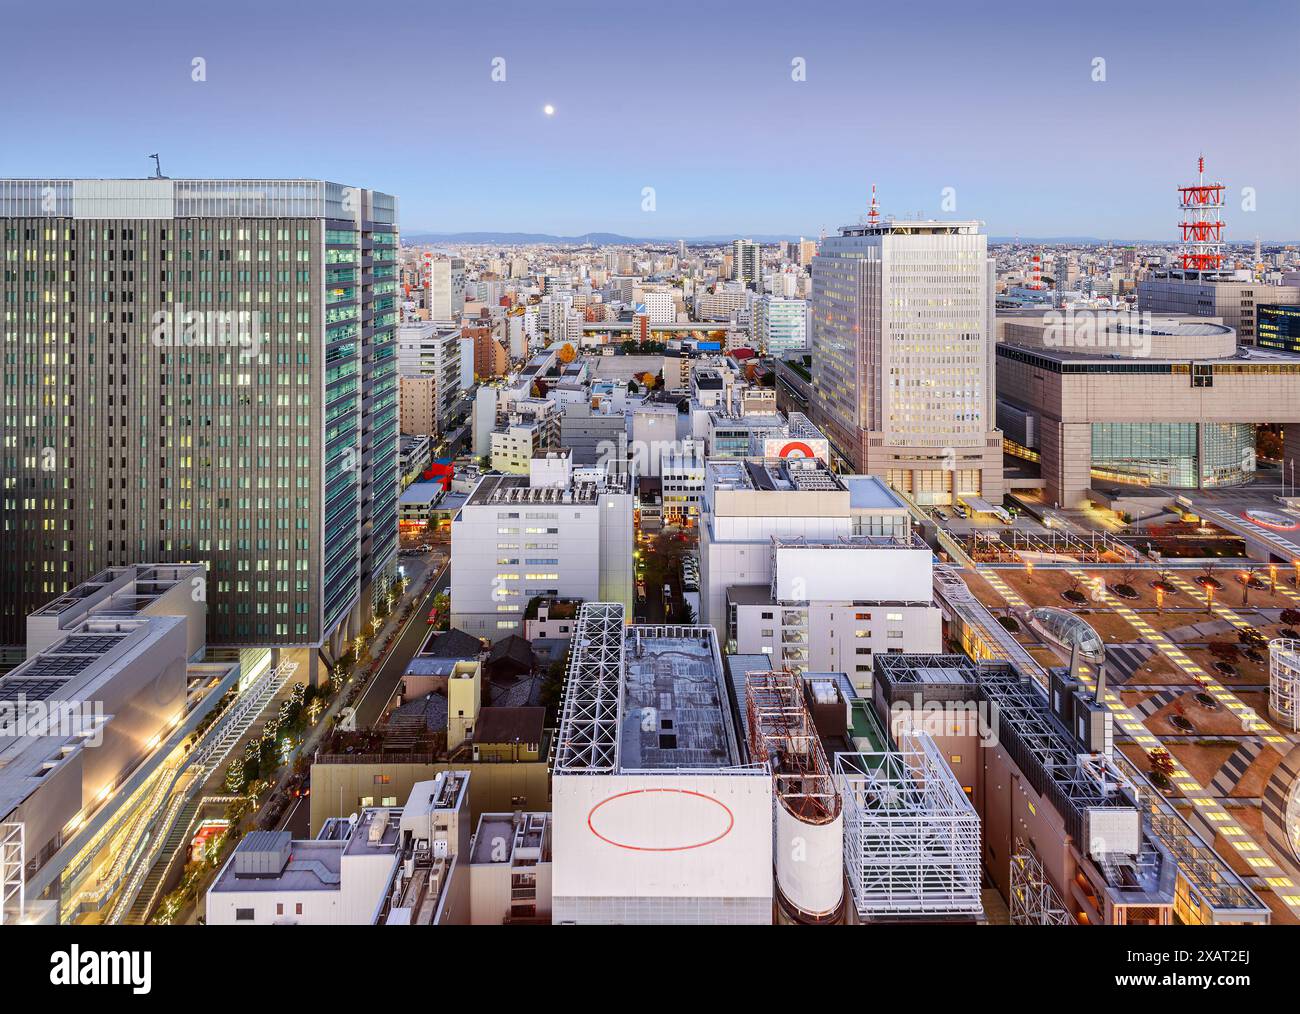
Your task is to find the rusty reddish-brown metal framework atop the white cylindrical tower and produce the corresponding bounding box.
[745,670,841,824]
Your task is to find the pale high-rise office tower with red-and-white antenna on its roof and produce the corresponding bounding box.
[811,221,1002,503]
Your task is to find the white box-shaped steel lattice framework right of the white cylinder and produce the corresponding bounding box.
[835,729,984,922]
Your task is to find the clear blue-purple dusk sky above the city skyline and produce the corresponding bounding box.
[0,0,1300,242]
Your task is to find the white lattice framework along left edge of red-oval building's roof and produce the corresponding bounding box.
[554,602,624,775]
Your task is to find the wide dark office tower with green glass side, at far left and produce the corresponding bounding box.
[0,178,398,673]
